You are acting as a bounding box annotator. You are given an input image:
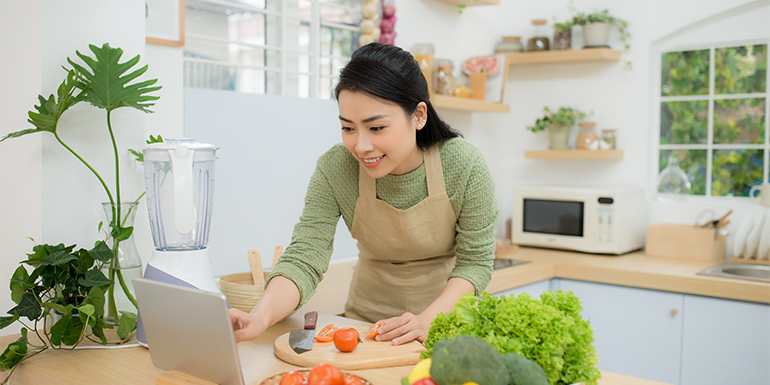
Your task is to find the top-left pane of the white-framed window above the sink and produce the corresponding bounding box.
[660,49,709,96]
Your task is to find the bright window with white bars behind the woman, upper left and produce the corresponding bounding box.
[183,0,361,99]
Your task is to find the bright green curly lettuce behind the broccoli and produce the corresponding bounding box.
[421,290,600,385]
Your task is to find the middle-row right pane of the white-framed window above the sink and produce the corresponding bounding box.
[714,98,766,144]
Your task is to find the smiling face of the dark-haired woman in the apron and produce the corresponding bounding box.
[338,90,427,178]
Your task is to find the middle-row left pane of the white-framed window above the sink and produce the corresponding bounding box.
[660,100,708,144]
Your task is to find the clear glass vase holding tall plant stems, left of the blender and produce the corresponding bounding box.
[102,202,142,325]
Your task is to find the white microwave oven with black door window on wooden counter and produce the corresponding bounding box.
[511,186,646,254]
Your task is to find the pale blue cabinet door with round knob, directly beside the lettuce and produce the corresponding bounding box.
[554,279,684,384]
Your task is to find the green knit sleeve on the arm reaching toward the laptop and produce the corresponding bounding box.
[265,160,340,309]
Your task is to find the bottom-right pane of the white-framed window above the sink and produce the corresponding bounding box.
[711,150,764,197]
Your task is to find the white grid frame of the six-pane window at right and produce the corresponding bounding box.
[649,38,770,202]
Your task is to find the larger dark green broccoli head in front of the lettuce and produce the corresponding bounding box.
[430,335,510,385]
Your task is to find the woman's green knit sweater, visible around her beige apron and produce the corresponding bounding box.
[267,138,499,308]
